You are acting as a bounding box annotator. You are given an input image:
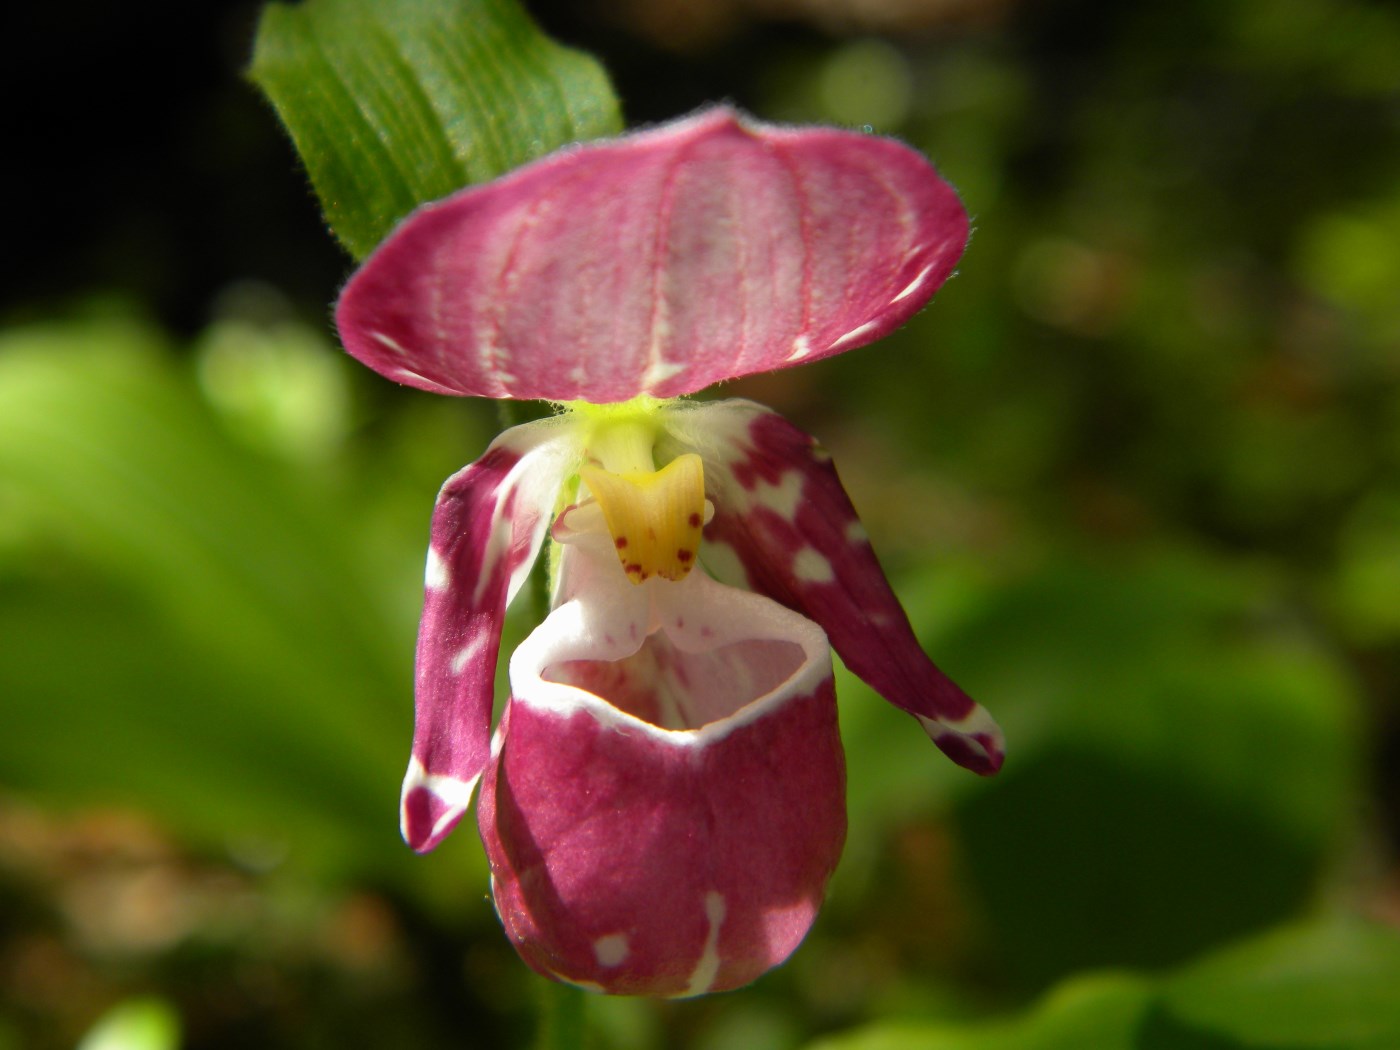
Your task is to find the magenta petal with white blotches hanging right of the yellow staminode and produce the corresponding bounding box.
[662,400,1004,774]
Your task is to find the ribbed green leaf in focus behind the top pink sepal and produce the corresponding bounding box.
[251,0,622,259]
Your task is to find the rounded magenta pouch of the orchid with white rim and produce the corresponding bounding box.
[477,573,846,997]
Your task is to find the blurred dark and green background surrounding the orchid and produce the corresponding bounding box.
[0,0,1400,1050]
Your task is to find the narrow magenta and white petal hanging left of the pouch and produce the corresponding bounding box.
[399,419,580,853]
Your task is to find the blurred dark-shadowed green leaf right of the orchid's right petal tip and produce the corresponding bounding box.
[942,550,1359,984]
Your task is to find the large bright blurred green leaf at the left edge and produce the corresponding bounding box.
[0,322,417,865]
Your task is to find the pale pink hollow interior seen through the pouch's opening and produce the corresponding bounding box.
[540,631,808,731]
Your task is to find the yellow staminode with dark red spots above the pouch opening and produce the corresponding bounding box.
[578,452,704,584]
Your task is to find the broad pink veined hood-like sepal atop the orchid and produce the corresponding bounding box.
[336,108,967,402]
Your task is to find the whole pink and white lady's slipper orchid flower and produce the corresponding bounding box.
[336,108,1002,997]
